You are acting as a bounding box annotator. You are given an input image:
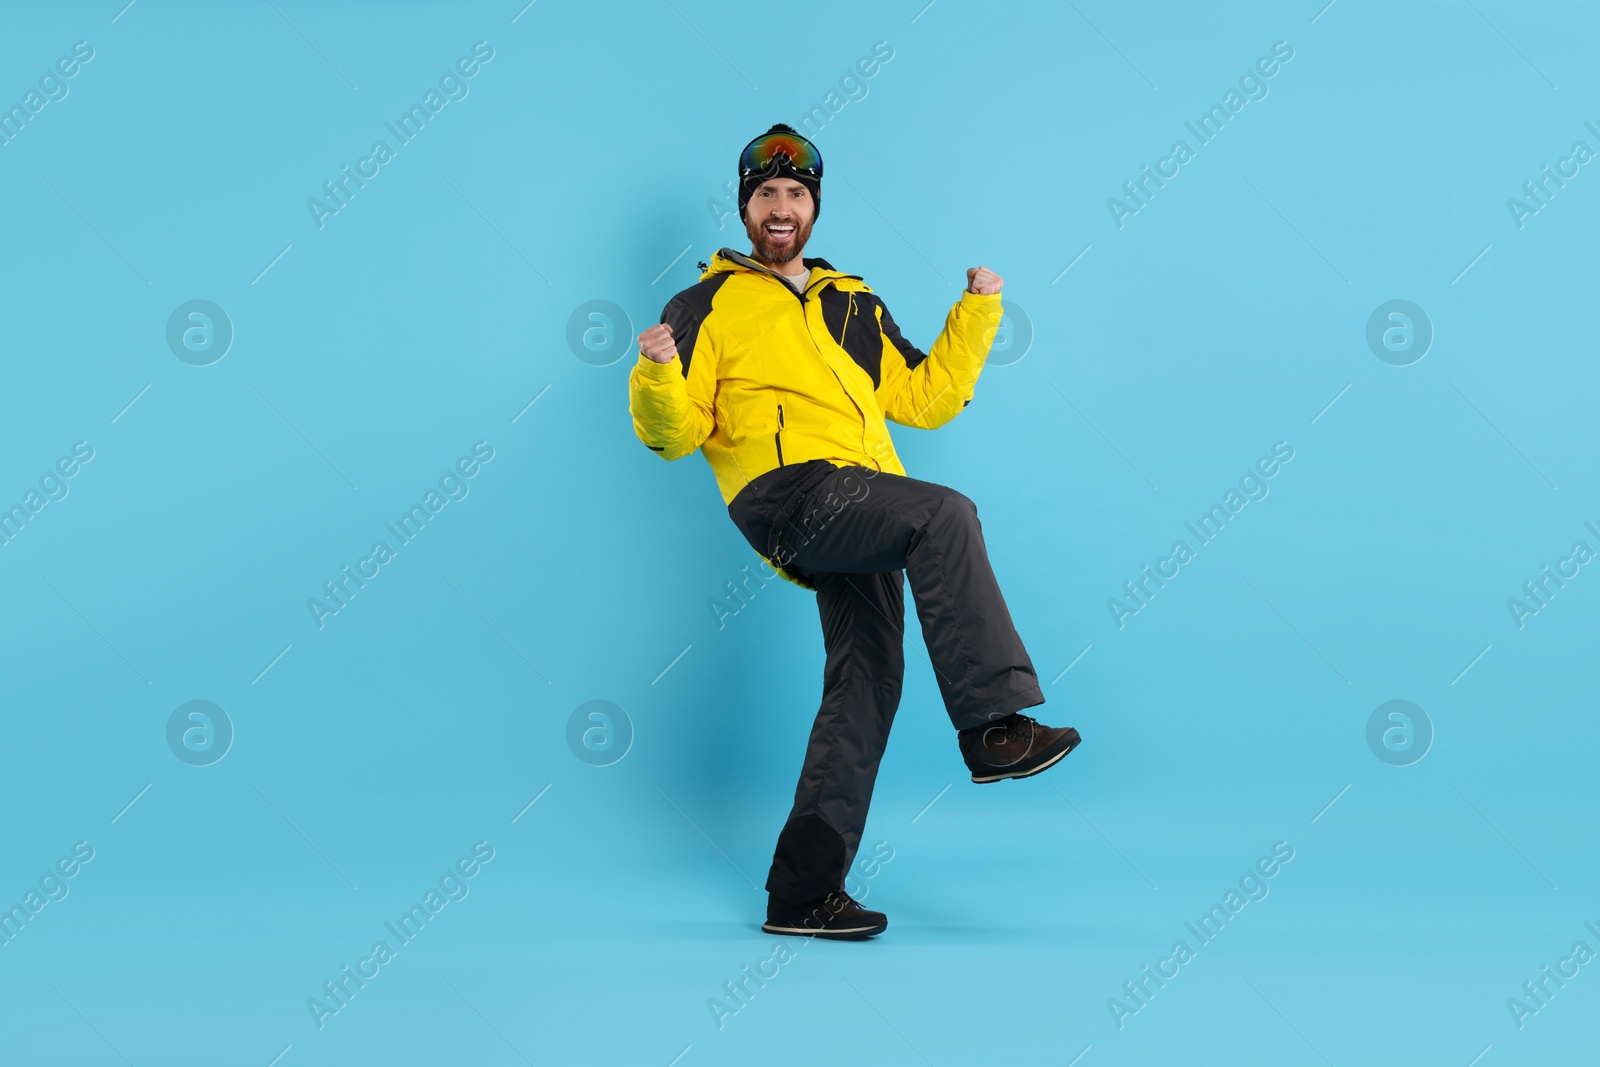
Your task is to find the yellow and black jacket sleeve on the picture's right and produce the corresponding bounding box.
[877,290,1002,430]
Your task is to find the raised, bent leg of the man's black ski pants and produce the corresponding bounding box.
[776,467,1045,729]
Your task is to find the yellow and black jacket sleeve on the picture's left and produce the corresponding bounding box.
[627,298,717,459]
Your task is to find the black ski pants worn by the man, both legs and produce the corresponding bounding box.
[730,461,1045,904]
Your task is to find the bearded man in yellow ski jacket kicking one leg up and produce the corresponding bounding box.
[629,123,1078,939]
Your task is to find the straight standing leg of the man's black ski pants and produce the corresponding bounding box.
[766,571,906,904]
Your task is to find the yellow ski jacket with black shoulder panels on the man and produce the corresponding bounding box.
[629,248,1002,589]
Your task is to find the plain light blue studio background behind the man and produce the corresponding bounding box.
[0,0,1600,1067]
